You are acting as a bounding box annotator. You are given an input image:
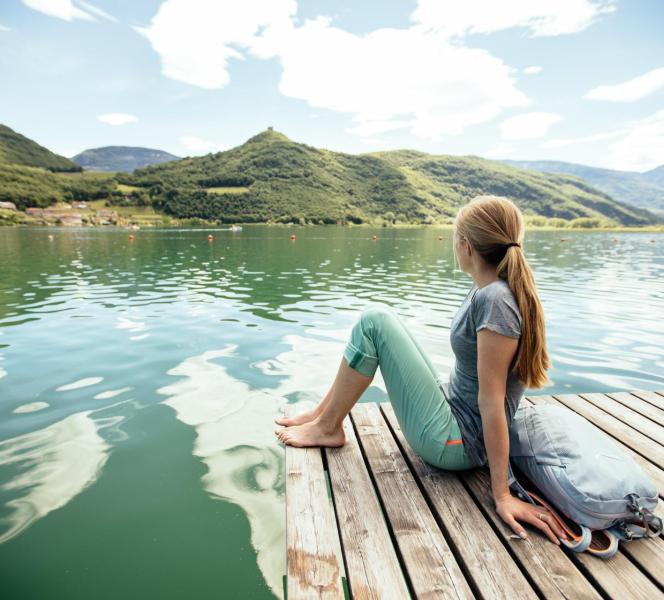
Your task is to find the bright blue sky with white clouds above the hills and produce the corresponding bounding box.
[0,0,664,171]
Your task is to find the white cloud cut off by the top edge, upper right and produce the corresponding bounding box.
[411,0,615,37]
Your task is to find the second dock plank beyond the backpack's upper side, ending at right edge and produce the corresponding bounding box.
[553,394,664,468]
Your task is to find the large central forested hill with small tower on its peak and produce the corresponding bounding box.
[121,129,657,225]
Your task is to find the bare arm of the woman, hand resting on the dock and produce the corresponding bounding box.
[477,329,564,544]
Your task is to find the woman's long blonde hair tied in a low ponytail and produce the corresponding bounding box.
[454,196,552,388]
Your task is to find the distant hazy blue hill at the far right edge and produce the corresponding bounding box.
[503,160,664,216]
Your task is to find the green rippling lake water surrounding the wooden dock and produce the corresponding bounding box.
[0,226,664,600]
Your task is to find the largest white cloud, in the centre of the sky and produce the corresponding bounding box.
[252,18,529,139]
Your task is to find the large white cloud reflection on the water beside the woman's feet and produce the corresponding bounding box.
[158,330,384,597]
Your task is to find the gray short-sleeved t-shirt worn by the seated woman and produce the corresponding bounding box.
[448,279,524,466]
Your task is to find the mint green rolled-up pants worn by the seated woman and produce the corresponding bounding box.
[344,304,472,471]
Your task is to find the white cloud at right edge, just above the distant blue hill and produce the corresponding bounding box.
[604,110,664,171]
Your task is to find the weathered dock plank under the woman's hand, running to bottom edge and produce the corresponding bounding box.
[461,469,601,600]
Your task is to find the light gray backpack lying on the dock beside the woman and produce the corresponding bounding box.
[509,402,662,539]
